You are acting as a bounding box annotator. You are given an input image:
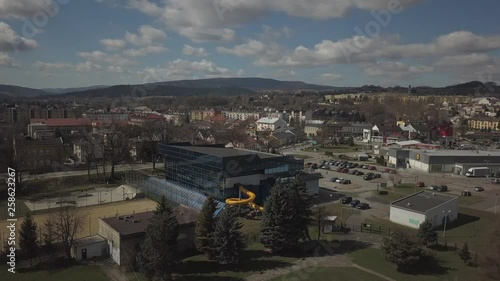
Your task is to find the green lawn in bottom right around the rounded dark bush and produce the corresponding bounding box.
[349,248,479,281]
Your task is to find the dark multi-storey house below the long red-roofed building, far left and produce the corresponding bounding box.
[14,137,64,172]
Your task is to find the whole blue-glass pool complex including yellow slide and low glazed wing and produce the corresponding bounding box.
[127,143,322,211]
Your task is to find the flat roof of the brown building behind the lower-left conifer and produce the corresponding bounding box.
[102,206,198,236]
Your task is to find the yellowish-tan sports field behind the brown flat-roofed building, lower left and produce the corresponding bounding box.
[0,199,157,245]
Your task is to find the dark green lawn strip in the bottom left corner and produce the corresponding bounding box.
[0,265,109,281]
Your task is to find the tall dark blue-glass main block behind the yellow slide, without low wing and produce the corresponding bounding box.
[159,143,304,201]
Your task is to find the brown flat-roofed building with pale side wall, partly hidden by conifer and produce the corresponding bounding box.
[99,206,198,270]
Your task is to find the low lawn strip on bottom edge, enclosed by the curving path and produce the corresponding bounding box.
[271,267,384,281]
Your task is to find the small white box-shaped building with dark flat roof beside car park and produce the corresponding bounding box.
[390,191,458,228]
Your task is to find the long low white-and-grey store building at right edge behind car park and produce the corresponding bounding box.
[388,148,500,175]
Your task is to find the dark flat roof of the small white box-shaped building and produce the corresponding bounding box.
[391,191,458,214]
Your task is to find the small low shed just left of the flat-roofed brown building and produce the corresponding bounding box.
[71,235,108,260]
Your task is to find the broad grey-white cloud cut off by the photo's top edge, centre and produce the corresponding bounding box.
[128,0,426,42]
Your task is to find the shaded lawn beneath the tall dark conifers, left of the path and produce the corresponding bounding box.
[176,243,299,281]
